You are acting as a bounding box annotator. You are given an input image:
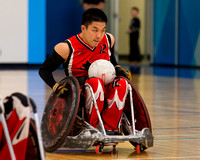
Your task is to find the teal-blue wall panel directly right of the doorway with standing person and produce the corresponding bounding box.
[154,0,175,64]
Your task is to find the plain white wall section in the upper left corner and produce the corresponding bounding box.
[0,0,28,63]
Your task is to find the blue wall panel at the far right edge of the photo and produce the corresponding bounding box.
[179,0,200,66]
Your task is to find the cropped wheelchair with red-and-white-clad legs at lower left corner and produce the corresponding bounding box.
[0,92,45,160]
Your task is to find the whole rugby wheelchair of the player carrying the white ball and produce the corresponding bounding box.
[41,76,154,154]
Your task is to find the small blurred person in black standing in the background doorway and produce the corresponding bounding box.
[127,7,140,63]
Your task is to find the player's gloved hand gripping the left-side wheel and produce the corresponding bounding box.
[53,83,68,98]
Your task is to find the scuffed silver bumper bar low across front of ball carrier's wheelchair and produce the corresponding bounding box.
[62,128,154,149]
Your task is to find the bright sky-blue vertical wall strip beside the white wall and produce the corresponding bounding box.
[28,0,46,64]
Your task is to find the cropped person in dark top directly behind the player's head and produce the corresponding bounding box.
[83,0,105,11]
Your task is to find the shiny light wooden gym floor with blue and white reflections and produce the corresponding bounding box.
[0,66,200,160]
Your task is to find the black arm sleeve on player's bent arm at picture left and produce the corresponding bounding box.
[39,50,65,88]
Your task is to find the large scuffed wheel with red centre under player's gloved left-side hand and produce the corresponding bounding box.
[41,77,80,152]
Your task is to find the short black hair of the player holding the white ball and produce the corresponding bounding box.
[82,8,108,27]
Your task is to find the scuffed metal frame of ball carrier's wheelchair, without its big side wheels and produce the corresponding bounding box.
[40,78,154,154]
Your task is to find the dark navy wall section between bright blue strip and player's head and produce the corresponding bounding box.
[46,0,83,54]
